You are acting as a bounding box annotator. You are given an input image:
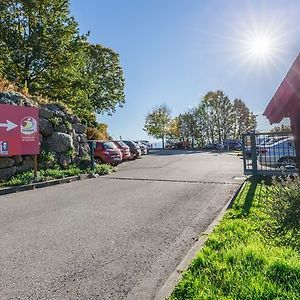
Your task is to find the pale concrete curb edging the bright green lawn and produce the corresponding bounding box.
[153,180,247,300]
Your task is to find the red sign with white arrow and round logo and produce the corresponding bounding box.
[0,104,40,156]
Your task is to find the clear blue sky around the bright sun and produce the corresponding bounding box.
[71,0,300,140]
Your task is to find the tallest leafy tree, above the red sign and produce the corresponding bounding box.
[0,0,85,93]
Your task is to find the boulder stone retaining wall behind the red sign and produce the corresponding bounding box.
[0,92,89,179]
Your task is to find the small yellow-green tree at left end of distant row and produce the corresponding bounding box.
[144,104,171,148]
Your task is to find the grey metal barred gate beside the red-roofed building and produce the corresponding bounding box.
[242,132,298,175]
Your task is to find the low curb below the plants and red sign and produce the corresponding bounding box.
[0,174,92,196]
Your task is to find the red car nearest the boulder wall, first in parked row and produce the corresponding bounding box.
[94,141,122,165]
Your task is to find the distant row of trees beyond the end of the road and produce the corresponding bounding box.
[144,91,257,147]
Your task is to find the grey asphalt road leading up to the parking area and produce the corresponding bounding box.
[0,151,242,300]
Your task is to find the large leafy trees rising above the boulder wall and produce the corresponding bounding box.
[0,0,125,126]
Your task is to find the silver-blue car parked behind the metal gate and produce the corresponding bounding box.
[258,137,297,168]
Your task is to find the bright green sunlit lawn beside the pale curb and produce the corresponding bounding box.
[170,181,300,300]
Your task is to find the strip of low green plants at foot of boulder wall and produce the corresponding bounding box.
[0,164,116,188]
